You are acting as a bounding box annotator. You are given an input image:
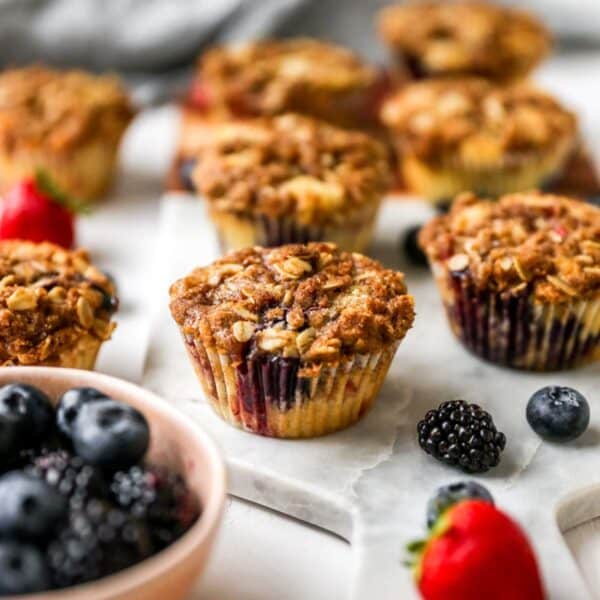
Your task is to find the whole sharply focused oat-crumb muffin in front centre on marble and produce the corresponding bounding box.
[170,243,414,438]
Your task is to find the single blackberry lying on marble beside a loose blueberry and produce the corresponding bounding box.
[417,400,506,473]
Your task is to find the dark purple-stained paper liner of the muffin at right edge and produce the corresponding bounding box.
[436,265,600,371]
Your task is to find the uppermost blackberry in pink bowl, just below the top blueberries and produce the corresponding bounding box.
[26,450,108,510]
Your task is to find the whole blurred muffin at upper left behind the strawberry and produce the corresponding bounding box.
[0,66,133,200]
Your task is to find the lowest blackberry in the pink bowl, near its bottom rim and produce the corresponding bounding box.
[46,499,152,588]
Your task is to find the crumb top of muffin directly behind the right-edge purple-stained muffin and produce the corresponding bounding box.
[381,78,577,165]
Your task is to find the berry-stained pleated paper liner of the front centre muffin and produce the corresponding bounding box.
[184,338,398,438]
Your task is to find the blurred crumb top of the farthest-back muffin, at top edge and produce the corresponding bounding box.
[378,0,551,80]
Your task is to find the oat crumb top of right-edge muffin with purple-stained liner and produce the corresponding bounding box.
[419,192,600,303]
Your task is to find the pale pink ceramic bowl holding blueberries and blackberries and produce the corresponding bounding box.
[0,367,225,600]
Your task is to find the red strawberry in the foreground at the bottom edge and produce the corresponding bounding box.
[409,500,545,600]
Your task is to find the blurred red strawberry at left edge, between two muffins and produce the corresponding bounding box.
[0,172,87,248]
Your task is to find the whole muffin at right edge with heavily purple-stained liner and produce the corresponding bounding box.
[420,193,600,371]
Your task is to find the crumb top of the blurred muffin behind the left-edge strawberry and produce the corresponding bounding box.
[0,66,133,152]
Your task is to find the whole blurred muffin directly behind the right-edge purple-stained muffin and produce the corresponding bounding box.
[381,79,577,201]
